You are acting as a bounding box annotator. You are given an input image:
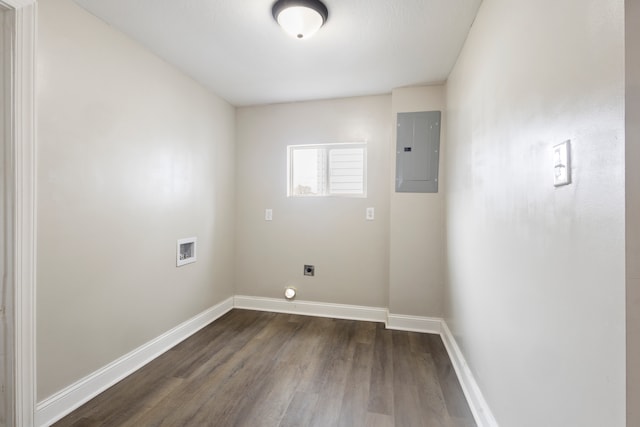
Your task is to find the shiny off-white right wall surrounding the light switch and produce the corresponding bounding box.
[445,0,625,427]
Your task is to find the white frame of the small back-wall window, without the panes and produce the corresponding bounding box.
[287,141,368,199]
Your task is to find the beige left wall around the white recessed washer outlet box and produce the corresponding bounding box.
[37,0,234,399]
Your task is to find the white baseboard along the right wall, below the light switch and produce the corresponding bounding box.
[440,320,498,427]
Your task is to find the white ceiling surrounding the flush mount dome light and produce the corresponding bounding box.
[76,0,482,106]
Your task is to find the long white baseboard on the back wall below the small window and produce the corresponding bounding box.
[234,295,387,322]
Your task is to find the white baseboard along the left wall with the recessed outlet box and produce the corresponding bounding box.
[35,297,233,426]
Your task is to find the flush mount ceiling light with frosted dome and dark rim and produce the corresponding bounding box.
[271,0,329,39]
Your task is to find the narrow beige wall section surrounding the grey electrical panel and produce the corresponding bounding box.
[389,86,446,317]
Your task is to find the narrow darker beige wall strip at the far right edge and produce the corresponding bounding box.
[625,1,640,427]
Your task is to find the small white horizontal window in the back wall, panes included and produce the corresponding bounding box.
[287,143,367,197]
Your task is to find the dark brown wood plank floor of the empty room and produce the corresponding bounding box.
[55,310,475,427]
